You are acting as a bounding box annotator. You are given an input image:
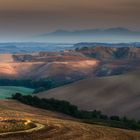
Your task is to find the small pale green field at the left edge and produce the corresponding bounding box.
[0,86,34,99]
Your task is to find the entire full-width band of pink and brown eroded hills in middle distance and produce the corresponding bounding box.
[0,47,140,82]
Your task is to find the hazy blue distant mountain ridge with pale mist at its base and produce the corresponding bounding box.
[36,27,140,43]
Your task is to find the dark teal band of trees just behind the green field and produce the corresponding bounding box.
[0,78,70,93]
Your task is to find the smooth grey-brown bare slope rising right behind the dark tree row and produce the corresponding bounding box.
[37,71,140,119]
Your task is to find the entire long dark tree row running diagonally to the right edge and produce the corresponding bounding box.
[12,93,140,130]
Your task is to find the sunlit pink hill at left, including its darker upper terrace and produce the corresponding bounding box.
[0,52,99,81]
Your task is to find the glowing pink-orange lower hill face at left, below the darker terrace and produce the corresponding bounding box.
[0,60,98,79]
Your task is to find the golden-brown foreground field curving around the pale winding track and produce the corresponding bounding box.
[0,100,140,140]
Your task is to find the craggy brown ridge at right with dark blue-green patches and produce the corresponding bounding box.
[76,46,140,60]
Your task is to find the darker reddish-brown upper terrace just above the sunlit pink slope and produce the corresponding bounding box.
[13,51,89,62]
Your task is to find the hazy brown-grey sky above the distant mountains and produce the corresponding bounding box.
[0,0,140,40]
